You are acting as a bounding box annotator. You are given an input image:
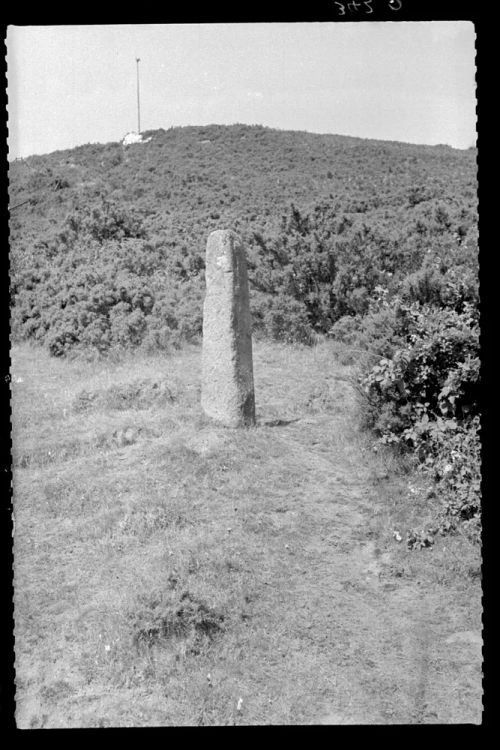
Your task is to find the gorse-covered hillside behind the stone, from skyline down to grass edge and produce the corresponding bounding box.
[10,125,477,354]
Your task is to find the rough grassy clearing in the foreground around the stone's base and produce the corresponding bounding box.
[11,343,482,728]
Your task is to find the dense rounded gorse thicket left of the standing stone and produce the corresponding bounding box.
[13,200,206,356]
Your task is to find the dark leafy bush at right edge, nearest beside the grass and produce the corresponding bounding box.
[356,286,481,541]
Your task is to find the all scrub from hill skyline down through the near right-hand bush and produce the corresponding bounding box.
[9,125,480,547]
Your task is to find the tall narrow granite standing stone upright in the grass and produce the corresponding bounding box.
[201,229,255,427]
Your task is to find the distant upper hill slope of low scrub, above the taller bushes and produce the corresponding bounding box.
[10,125,476,236]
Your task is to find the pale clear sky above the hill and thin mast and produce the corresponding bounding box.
[7,21,476,159]
